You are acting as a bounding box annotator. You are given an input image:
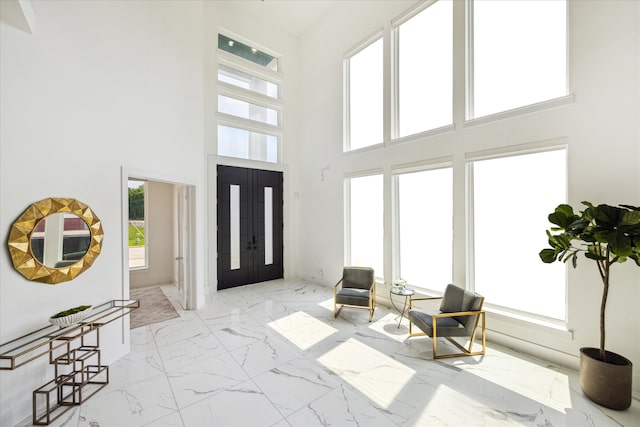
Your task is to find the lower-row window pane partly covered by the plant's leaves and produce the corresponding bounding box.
[473,150,567,320]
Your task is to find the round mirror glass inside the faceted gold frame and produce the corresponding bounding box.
[31,212,91,268]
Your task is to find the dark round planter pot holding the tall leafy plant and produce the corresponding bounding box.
[580,347,633,410]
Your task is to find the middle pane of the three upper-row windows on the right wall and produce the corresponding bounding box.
[397,0,453,137]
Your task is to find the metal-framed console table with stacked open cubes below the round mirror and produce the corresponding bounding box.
[0,300,140,425]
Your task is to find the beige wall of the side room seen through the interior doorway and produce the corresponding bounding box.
[129,181,176,289]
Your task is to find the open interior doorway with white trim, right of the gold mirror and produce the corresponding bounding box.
[123,168,196,310]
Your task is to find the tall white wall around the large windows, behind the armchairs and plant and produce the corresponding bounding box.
[297,1,640,393]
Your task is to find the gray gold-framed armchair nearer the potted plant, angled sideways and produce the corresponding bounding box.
[408,285,486,359]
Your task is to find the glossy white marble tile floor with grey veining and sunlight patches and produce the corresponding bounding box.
[20,280,640,427]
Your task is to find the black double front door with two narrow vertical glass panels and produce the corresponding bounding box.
[218,165,283,289]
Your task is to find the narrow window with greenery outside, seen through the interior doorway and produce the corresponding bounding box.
[129,179,147,268]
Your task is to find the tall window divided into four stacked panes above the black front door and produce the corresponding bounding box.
[217,34,282,163]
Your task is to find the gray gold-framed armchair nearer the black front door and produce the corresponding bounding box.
[333,267,376,322]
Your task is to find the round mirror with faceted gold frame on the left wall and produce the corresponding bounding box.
[9,197,104,285]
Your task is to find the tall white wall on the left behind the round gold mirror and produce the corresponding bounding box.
[0,1,205,425]
